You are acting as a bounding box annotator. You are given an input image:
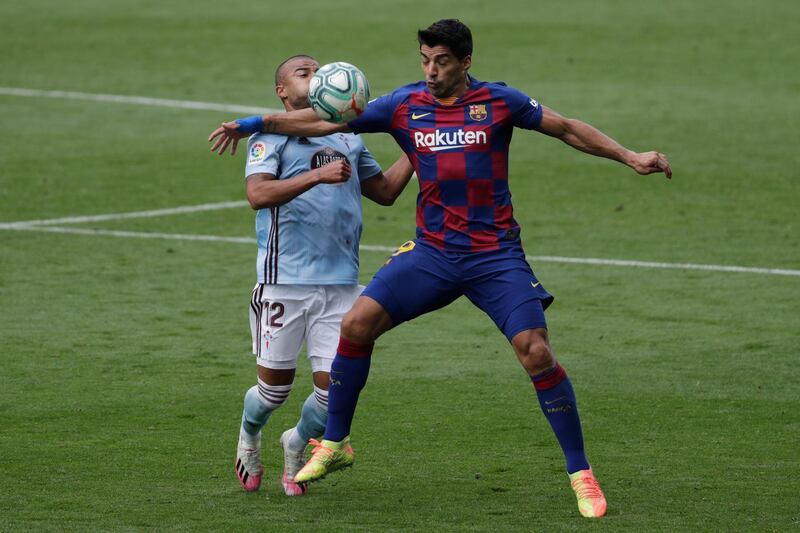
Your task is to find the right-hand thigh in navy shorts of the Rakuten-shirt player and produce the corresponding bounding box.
[464,252,553,341]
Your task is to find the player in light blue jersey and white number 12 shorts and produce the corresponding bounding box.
[227,55,413,496]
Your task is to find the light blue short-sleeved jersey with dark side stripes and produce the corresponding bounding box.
[245,133,381,285]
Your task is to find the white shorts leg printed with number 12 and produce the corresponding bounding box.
[250,285,314,369]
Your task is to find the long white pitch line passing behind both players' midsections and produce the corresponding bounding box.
[0,219,800,276]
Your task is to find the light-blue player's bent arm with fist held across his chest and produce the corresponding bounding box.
[246,159,353,209]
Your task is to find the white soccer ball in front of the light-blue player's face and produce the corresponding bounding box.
[308,61,369,124]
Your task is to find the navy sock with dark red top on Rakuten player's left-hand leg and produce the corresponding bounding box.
[324,338,374,442]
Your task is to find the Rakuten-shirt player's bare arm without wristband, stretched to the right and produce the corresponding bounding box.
[539,107,672,179]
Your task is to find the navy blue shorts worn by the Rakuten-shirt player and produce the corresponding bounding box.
[362,241,553,341]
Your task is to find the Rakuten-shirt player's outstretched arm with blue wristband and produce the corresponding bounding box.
[208,108,350,155]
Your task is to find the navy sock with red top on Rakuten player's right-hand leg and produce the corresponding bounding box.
[531,363,589,474]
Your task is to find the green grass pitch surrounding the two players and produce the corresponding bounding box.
[0,0,800,531]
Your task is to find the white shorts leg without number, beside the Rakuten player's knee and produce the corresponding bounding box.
[306,285,364,372]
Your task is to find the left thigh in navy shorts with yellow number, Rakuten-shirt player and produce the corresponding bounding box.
[362,241,462,326]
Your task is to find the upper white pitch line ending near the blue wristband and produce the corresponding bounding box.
[0,87,282,114]
